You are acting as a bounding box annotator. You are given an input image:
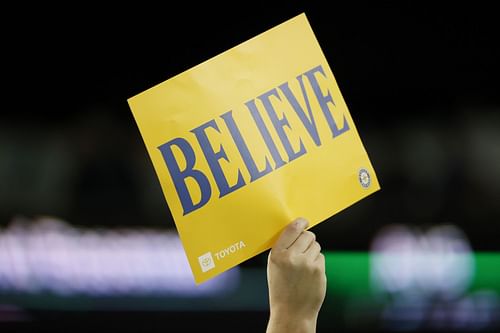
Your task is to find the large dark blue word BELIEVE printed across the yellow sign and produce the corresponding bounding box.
[158,65,350,215]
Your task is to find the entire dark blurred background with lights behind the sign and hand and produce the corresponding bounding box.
[0,1,500,332]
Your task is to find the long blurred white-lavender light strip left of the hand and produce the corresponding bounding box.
[0,218,240,296]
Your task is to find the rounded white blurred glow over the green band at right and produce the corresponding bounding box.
[371,224,475,299]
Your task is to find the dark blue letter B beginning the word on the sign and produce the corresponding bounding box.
[158,138,212,215]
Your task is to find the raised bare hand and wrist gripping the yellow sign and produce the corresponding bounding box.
[266,218,326,333]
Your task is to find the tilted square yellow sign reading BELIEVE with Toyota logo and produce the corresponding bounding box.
[128,13,380,284]
